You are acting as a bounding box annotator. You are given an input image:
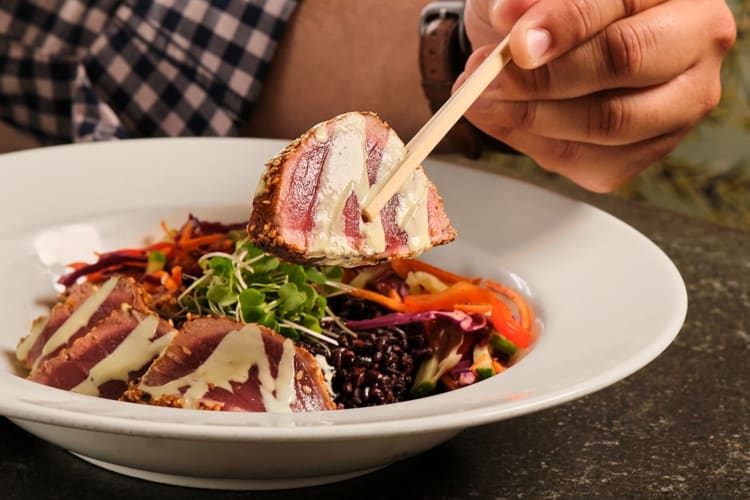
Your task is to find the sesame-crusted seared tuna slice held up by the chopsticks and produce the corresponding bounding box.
[248,113,456,267]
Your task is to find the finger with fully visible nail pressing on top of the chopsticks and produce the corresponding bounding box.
[510,0,666,69]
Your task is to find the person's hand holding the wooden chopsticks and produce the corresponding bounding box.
[454,0,736,192]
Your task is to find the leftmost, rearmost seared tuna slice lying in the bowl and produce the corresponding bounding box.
[16,276,144,370]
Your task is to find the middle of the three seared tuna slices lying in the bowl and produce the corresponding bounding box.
[29,306,177,399]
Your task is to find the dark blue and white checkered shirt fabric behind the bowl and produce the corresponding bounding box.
[0,0,297,144]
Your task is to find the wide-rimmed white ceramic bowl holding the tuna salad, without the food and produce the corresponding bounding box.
[0,139,687,489]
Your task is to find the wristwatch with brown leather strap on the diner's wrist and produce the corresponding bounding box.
[419,0,515,159]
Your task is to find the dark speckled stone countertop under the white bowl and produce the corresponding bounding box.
[0,178,750,500]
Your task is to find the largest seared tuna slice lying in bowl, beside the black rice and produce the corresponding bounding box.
[123,317,334,412]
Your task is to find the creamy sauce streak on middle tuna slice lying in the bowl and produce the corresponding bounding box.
[71,316,177,396]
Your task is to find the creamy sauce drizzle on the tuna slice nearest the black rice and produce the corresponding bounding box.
[139,325,297,412]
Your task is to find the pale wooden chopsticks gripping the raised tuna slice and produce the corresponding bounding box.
[362,36,511,221]
